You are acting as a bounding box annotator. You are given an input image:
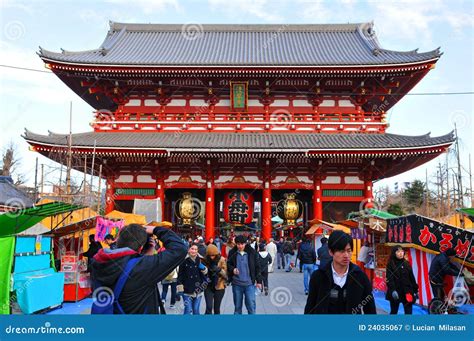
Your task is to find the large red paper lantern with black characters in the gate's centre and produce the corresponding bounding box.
[224,190,254,225]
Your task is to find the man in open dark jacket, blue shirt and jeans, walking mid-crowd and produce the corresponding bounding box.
[227,235,262,315]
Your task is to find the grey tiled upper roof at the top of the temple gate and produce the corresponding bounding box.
[39,23,441,67]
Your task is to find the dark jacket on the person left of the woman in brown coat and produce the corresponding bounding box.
[178,255,209,295]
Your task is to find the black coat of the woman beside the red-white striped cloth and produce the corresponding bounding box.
[385,260,418,302]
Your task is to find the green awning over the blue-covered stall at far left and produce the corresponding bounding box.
[0,202,84,237]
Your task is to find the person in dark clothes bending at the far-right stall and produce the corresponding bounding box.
[429,249,460,300]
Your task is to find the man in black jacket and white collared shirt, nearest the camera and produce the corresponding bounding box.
[304,231,376,314]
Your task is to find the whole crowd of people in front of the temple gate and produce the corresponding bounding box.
[84,224,459,315]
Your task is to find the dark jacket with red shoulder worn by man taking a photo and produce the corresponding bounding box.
[92,227,187,314]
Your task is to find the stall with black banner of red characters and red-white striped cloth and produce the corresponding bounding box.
[386,214,474,306]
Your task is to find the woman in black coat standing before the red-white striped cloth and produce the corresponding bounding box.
[385,245,418,315]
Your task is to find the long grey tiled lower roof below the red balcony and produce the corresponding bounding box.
[23,130,454,152]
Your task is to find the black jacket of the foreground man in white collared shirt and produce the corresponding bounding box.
[304,263,376,314]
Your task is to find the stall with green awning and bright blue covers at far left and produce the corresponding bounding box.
[0,202,81,314]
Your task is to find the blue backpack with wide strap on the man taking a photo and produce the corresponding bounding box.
[91,257,166,315]
